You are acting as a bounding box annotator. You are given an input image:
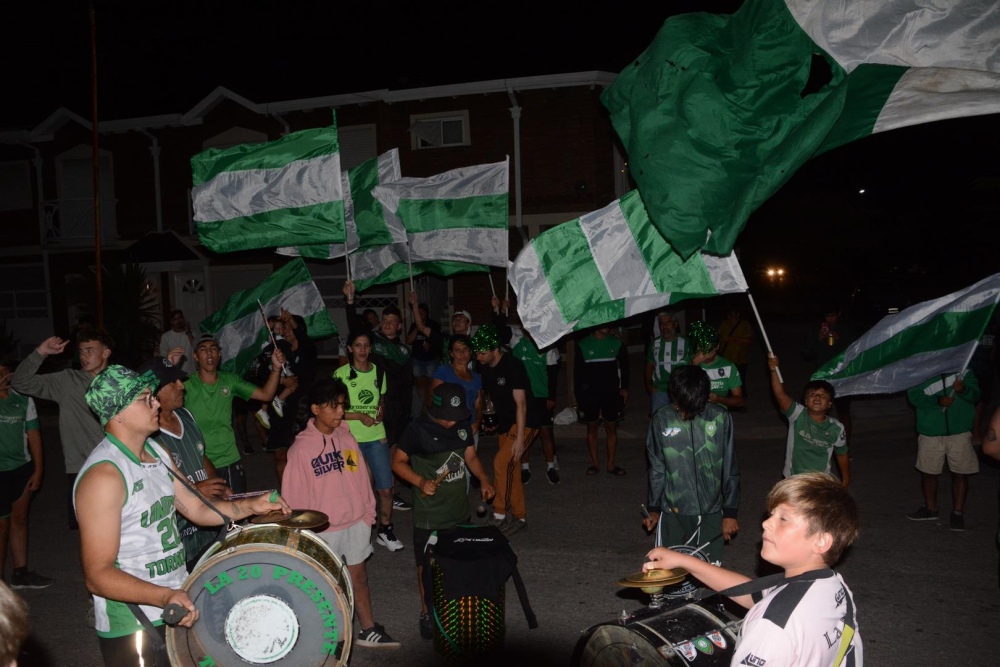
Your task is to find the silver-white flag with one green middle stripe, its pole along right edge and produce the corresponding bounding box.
[372,160,510,267]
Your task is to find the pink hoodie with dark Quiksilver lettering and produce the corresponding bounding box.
[281,419,375,532]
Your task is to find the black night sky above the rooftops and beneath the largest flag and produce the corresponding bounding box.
[9,0,1000,308]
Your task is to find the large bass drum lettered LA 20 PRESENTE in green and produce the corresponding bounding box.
[167,524,354,667]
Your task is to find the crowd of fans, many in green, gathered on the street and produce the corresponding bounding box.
[0,294,1000,665]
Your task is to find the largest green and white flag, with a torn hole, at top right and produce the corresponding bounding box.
[602,0,1000,257]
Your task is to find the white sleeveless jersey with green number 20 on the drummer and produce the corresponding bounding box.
[73,434,187,637]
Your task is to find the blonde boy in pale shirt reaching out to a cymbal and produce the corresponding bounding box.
[642,472,863,667]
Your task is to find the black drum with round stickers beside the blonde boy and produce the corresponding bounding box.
[572,602,742,667]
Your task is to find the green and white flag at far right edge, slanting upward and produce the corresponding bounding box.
[812,273,1000,396]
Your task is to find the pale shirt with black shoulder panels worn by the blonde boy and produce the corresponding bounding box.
[730,570,864,667]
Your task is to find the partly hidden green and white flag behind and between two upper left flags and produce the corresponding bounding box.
[277,148,406,262]
